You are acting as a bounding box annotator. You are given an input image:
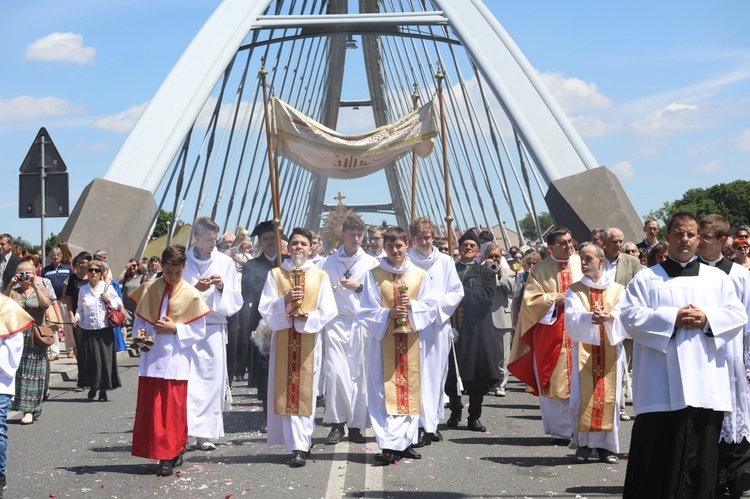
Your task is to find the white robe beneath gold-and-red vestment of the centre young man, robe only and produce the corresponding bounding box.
[357,257,436,451]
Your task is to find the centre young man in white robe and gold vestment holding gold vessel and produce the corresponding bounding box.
[357,227,435,463]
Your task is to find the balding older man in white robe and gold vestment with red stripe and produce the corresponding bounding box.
[565,243,626,464]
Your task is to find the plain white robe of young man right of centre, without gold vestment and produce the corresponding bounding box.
[409,247,464,433]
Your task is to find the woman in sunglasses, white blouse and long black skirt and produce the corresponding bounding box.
[73,260,123,402]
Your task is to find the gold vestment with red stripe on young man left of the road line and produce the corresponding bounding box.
[272,267,326,416]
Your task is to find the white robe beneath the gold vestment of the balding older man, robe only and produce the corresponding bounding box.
[565,274,627,454]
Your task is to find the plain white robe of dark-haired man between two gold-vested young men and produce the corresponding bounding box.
[318,246,379,430]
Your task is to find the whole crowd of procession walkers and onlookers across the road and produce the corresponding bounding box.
[0,213,750,497]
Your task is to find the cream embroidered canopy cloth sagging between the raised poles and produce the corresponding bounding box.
[271,97,438,179]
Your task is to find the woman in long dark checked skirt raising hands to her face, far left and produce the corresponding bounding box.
[4,262,50,425]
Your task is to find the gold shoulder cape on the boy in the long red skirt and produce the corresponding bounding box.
[128,277,211,325]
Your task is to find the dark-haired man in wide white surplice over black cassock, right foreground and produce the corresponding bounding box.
[620,213,747,498]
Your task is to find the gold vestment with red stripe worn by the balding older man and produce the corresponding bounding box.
[571,282,625,431]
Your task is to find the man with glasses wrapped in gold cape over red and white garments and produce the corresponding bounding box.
[508,227,583,446]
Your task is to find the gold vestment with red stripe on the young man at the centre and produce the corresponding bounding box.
[372,267,424,416]
